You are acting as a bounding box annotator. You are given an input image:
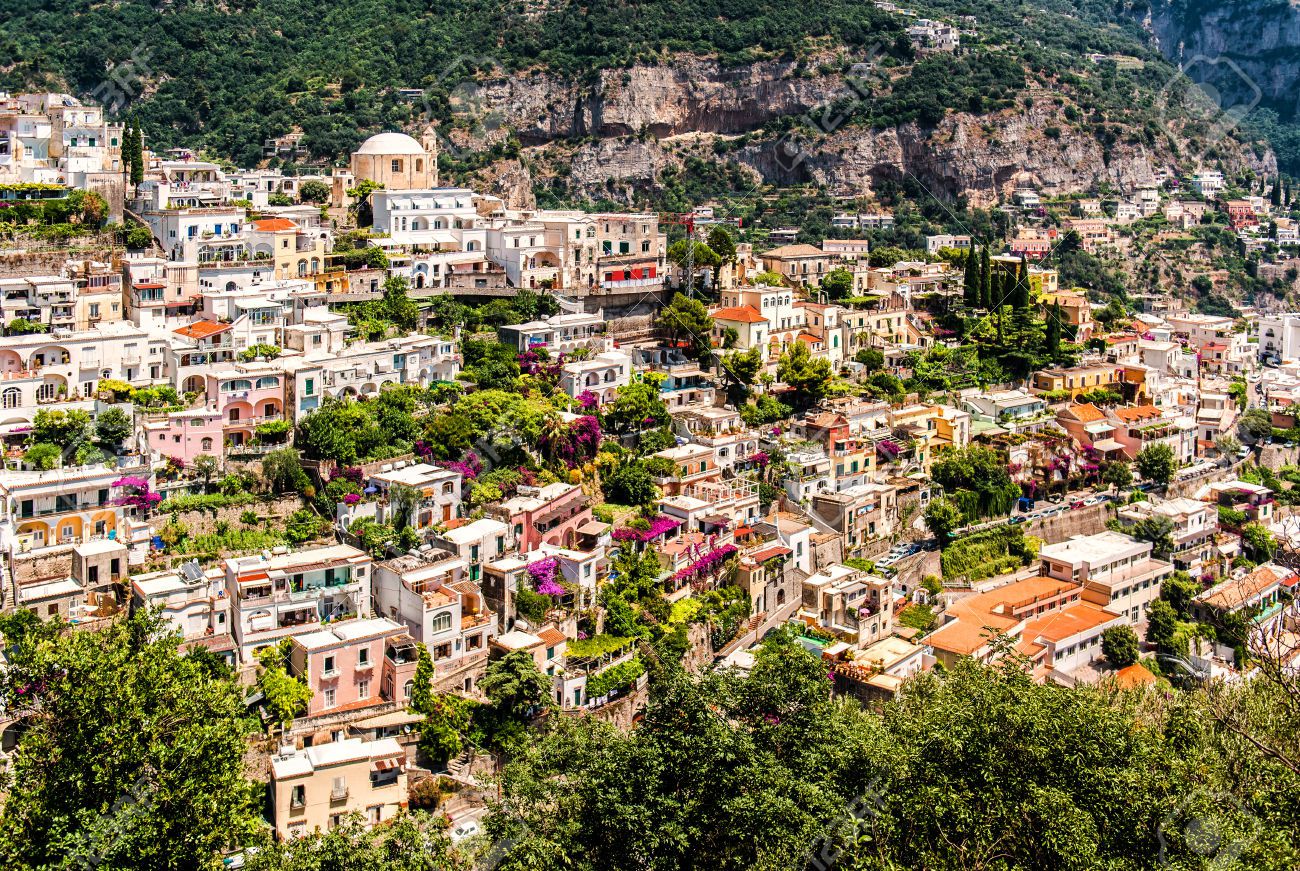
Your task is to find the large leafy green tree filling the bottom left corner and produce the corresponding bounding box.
[0,612,261,871]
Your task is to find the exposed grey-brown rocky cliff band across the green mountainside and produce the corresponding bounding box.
[462,59,1275,204]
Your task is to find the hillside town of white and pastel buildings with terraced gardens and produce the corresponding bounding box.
[0,88,1300,861]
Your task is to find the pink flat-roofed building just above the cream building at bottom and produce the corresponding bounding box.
[289,618,416,716]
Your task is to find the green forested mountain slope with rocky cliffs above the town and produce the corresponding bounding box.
[0,0,1275,204]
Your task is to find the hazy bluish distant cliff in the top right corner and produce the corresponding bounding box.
[1144,0,1300,117]
